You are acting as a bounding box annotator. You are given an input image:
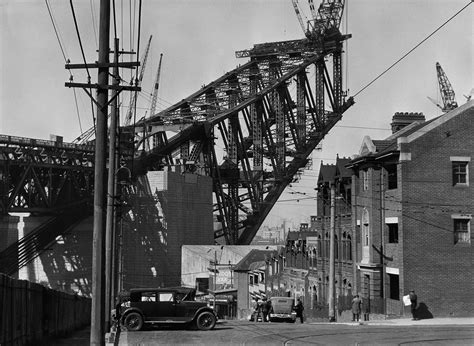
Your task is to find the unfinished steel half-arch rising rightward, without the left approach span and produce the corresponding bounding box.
[134,31,353,244]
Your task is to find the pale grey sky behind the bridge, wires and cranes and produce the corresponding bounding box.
[0,0,474,230]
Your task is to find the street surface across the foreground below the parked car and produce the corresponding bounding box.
[118,321,474,345]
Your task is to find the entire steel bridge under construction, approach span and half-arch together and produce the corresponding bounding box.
[0,0,354,273]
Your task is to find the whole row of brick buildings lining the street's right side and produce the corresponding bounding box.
[279,101,474,318]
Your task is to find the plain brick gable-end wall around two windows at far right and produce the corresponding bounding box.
[402,107,474,316]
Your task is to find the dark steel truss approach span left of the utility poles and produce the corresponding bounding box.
[0,135,94,214]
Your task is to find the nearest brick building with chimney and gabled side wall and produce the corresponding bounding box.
[348,101,474,317]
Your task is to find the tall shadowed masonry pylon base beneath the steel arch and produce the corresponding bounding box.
[123,171,214,288]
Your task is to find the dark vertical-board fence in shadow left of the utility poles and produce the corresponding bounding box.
[0,274,91,345]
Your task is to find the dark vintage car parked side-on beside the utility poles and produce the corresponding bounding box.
[112,287,217,331]
